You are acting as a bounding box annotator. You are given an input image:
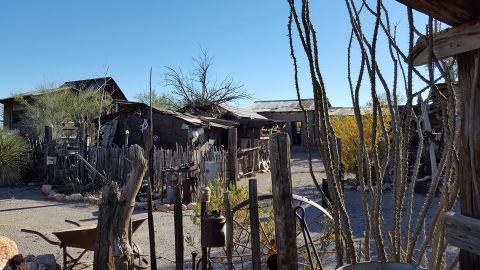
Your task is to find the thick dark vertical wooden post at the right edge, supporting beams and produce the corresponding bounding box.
[458,50,480,269]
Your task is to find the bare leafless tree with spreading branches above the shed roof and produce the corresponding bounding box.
[165,50,251,113]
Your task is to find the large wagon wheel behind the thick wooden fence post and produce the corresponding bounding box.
[212,194,333,269]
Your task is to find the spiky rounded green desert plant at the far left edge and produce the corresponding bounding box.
[0,129,30,185]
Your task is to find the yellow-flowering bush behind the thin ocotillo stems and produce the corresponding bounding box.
[330,113,389,173]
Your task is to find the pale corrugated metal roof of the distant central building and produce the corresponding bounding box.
[248,99,371,115]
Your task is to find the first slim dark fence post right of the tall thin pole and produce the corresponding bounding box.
[173,180,184,270]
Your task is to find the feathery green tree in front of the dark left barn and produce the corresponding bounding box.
[16,88,110,137]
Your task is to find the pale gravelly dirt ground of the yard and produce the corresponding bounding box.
[0,148,455,269]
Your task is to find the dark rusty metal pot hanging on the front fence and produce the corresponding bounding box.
[201,210,227,247]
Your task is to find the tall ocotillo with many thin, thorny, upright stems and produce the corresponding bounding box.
[288,0,461,269]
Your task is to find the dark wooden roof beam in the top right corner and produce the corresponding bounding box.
[397,0,480,25]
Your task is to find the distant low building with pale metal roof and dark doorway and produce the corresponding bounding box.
[248,99,370,147]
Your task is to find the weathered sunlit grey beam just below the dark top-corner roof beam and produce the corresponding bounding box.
[411,20,480,66]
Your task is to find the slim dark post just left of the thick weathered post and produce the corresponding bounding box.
[248,179,262,270]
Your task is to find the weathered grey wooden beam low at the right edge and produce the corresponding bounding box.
[445,212,480,255]
